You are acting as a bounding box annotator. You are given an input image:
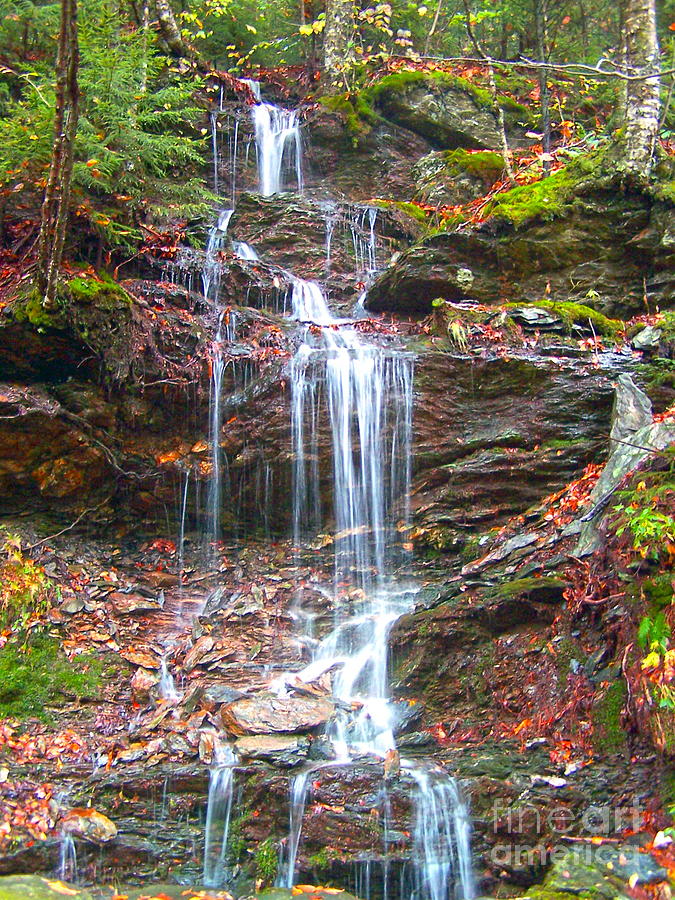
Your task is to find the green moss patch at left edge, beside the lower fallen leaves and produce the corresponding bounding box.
[0,635,100,720]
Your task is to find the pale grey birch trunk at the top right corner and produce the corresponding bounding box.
[623,0,660,179]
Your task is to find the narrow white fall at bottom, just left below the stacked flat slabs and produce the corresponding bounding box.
[204,742,237,887]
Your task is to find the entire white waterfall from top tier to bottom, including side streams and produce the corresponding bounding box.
[203,82,475,900]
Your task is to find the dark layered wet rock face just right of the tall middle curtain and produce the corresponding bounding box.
[412,353,612,549]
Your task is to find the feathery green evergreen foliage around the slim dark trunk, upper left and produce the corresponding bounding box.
[0,0,213,247]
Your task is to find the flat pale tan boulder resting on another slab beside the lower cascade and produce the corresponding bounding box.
[220,693,335,735]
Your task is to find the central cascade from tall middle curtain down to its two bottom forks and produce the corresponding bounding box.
[274,280,474,900]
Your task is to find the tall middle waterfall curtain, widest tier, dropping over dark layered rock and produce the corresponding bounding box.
[291,279,413,590]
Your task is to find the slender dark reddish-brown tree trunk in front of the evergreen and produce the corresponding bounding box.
[37,0,79,309]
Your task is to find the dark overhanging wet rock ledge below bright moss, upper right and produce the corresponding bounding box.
[366,192,675,318]
